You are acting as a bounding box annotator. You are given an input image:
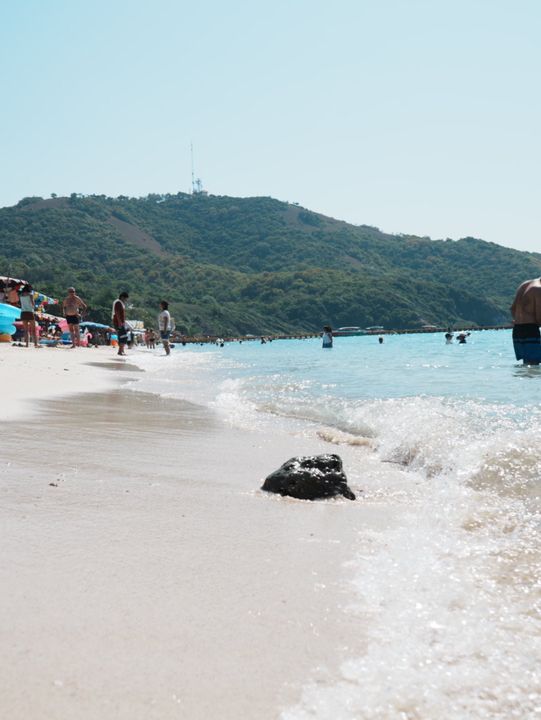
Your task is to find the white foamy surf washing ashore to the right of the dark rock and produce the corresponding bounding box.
[282,398,541,720]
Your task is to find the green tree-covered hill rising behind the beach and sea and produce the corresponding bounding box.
[0,193,541,334]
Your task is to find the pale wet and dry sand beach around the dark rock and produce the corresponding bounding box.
[0,346,382,720]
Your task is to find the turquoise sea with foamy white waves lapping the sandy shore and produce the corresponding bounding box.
[129,331,541,720]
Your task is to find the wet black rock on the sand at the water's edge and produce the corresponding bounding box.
[261,454,355,500]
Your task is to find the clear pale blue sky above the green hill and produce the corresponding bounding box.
[0,0,541,252]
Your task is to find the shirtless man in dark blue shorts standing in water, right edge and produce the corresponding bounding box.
[511,278,541,365]
